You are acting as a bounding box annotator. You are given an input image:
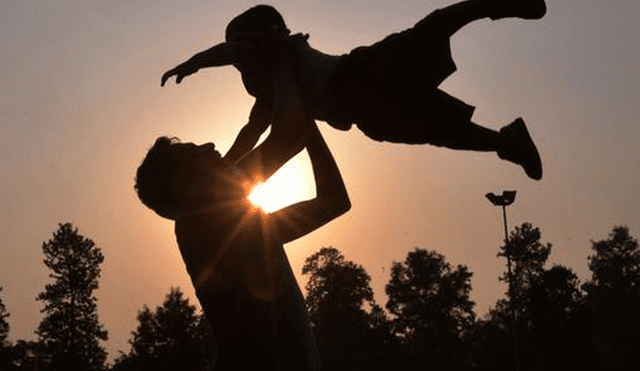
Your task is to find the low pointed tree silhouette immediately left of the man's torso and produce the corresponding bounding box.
[113,288,214,370]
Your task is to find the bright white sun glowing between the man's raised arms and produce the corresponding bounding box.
[247,158,313,213]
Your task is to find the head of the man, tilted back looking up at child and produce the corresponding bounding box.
[134,137,230,220]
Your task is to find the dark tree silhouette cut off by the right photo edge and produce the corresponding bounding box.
[584,226,640,370]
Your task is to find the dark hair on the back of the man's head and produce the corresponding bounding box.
[134,137,200,219]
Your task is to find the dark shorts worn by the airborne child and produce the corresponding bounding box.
[326,11,474,146]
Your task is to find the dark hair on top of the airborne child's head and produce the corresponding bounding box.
[226,5,291,41]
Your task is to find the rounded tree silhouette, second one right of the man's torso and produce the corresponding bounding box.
[385,248,475,369]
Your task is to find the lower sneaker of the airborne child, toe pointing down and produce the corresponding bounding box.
[498,118,542,180]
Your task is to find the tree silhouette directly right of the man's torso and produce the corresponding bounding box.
[302,247,385,370]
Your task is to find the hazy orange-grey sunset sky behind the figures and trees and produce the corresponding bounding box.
[0,0,640,359]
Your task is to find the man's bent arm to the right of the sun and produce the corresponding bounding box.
[269,120,351,243]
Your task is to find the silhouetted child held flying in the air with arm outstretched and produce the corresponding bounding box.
[161,0,546,180]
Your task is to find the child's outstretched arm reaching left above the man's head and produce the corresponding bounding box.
[160,42,246,86]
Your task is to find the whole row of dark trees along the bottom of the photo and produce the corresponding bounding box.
[0,223,640,371]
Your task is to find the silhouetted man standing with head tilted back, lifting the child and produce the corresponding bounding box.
[135,118,351,370]
